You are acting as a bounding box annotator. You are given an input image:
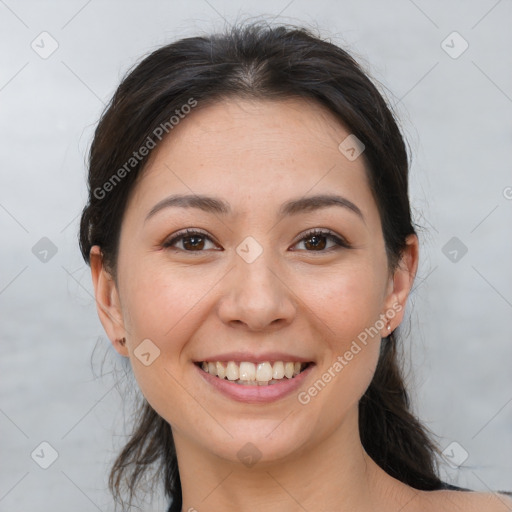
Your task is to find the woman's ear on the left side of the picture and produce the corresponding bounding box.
[89,245,128,357]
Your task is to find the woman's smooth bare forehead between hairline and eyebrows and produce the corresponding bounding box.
[126,99,373,222]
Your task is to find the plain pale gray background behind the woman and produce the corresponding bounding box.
[0,0,512,512]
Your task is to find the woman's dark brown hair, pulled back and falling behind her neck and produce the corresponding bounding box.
[80,23,441,510]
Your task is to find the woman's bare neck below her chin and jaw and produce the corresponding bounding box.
[173,409,416,512]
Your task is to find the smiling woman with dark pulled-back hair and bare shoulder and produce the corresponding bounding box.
[80,25,512,512]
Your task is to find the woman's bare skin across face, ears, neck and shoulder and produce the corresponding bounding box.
[91,99,508,512]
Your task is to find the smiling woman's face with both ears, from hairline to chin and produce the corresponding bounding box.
[91,100,417,462]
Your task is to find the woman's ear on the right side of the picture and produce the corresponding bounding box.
[382,235,419,337]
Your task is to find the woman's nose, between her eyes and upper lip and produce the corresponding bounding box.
[218,251,296,331]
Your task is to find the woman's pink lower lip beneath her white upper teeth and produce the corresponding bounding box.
[194,363,315,404]
